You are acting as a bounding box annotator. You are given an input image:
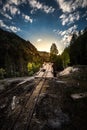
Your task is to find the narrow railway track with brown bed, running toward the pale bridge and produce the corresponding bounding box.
[11,69,47,130]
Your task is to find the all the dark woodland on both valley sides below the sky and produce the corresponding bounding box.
[0,28,87,78]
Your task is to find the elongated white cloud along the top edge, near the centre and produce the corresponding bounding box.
[28,0,55,14]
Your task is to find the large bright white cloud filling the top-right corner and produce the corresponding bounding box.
[56,0,87,13]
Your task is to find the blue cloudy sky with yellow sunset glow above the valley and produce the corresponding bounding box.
[0,0,87,54]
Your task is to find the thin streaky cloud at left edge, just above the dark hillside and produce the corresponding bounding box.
[0,20,20,33]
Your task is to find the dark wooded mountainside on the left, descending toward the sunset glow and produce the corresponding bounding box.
[0,29,40,75]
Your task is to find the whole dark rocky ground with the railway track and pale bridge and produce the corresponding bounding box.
[0,64,87,130]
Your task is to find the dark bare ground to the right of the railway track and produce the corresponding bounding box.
[30,68,87,130]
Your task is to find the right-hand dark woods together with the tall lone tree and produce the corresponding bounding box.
[50,28,87,71]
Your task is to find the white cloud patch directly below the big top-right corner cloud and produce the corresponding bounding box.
[59,12,80,25]
